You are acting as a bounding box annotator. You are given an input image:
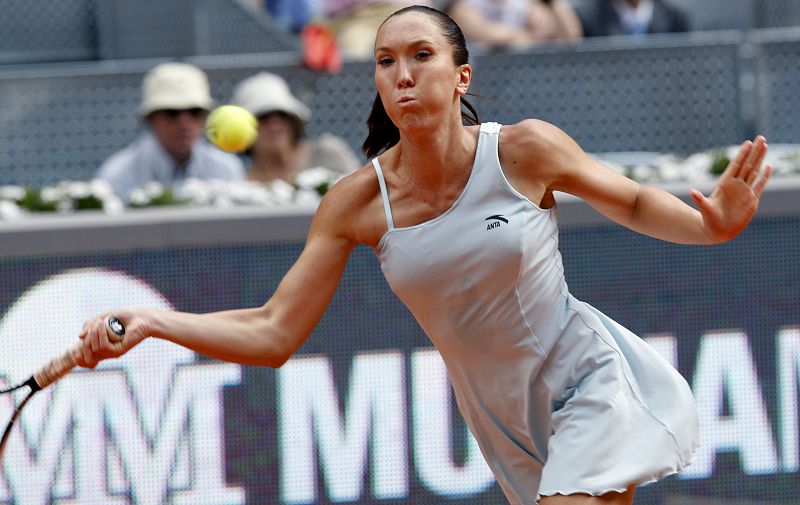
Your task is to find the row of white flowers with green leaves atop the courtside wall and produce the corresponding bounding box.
[0,145,800,220]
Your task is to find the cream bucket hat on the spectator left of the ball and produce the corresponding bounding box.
[139,63,214,117]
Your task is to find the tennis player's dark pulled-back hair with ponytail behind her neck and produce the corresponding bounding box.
[361,5,480,158]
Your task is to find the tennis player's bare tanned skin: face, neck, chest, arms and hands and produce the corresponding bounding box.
[79,8,771,505]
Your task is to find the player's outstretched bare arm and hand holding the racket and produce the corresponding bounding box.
[78,180,356,367]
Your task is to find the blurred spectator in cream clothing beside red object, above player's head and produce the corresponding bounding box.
[317,0,431,58]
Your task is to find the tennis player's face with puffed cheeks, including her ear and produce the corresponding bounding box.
[375,12,469,130]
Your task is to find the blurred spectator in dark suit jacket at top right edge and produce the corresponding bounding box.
[578,0,689,37]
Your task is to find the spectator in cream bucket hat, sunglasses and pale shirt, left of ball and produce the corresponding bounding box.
[97,63,244,200]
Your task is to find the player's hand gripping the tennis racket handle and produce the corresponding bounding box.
[76,309,152,368]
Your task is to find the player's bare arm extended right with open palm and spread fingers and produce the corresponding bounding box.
[503,120,770,244]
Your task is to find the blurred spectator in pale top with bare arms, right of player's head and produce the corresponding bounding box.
[448,0,582,48]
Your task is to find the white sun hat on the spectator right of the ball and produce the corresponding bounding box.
[231,72,311,122]
